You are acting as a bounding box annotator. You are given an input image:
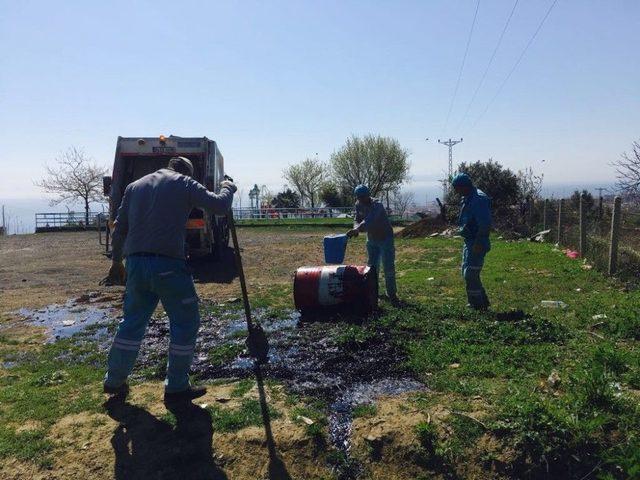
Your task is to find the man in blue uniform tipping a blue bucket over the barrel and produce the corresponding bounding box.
[347,185,399,304]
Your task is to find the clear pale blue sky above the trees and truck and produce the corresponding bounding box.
[0,0,640,227]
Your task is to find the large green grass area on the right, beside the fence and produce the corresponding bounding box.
[378,238,640,478]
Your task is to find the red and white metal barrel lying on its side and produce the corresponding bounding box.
[293,265,378,312]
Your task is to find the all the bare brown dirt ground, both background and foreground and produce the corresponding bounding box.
[0,228,419,480]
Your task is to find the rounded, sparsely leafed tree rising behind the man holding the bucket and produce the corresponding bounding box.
[330,135,410,196]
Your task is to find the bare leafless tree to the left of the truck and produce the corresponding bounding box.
[35,147,106,226]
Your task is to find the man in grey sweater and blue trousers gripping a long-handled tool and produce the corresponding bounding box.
[104,157,236,402]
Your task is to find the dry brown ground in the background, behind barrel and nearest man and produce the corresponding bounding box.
[0,228,365,318]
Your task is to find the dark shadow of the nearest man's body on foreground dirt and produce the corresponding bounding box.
[104,398,227,480]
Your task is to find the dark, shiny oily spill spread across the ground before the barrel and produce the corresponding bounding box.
[7,298,425,478]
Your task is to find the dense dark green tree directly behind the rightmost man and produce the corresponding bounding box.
[447,158,522,209]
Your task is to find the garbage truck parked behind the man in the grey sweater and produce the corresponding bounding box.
[103,135,229,258]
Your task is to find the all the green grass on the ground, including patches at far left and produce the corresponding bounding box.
[0,233,640,479]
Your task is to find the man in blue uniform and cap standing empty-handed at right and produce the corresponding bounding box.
[451,173,491,310]
